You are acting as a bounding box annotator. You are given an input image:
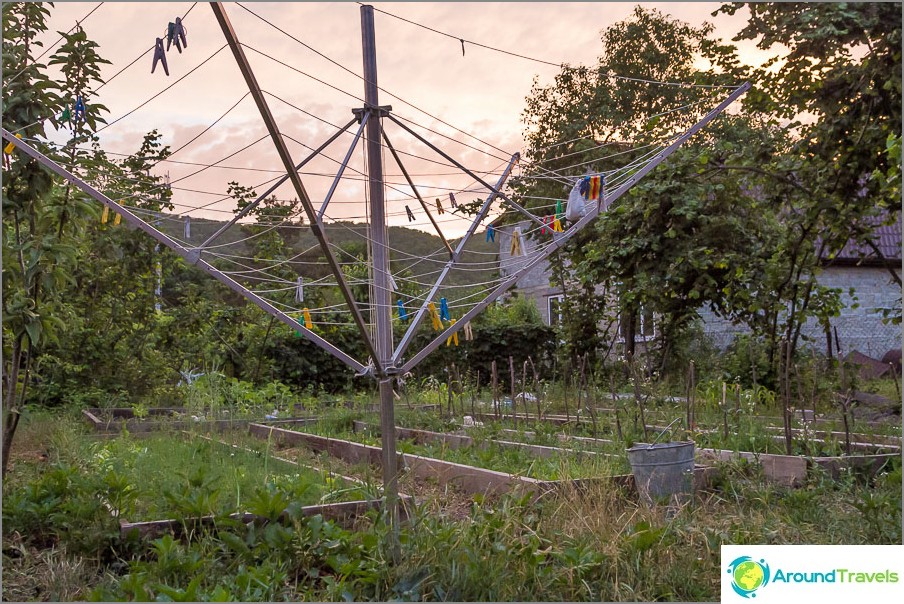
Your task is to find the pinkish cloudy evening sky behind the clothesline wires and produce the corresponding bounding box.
[31,2,767,236]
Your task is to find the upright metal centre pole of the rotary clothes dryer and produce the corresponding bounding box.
[361,5,400,562]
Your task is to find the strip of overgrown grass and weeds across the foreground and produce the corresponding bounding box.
[2,408,902,601]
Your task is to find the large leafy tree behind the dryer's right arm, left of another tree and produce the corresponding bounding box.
[519,7,768,370]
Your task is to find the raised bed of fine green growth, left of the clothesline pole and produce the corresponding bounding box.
[80,433,410,538]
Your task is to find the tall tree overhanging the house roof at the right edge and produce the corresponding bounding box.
[714,3,901,364]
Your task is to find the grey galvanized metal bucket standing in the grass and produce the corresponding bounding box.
[628,441,694,502]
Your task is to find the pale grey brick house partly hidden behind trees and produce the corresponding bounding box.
[495,221,901,359]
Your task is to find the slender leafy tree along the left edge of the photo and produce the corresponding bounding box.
[2,2,103,474]
